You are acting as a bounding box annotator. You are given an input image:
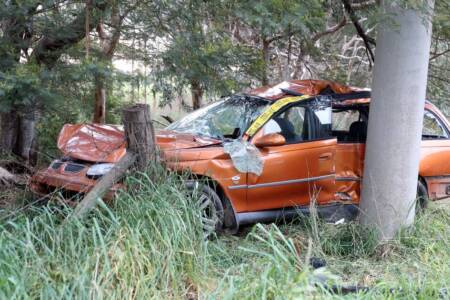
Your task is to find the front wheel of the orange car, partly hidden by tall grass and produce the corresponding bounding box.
[187,181,224,238]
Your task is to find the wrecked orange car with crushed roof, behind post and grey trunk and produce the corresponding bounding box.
[32,80,450,234]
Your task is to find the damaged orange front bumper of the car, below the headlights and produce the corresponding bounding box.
[30,169,124,202]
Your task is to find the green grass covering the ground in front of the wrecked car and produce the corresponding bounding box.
[0,170,450,299]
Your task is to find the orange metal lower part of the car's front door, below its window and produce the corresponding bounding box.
[243,139,336,211]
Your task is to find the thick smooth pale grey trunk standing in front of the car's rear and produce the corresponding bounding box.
[360,1,432,241]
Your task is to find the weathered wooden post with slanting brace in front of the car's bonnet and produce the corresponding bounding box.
[71,104,156,218]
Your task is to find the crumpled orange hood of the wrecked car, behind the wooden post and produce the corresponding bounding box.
[58,124,221,163]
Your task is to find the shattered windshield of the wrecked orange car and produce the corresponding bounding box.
[167,95,270,139]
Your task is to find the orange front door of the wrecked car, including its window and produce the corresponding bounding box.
[247,98,337,211]
